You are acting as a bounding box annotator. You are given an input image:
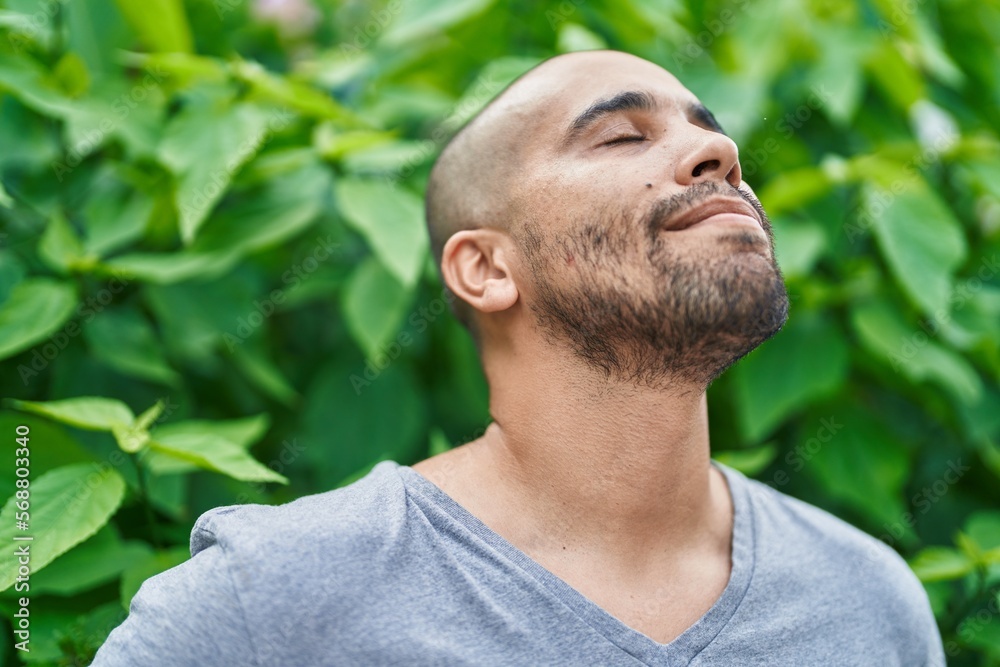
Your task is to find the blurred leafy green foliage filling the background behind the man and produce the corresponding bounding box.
[0,0,1000,665]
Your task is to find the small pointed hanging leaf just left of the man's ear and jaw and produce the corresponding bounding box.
[343,257,410,359]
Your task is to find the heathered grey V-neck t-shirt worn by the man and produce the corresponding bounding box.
[93,461,945,667]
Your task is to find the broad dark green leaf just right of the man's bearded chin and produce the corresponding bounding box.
[733,313,848,442]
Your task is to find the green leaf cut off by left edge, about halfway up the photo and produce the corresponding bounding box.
[0,278,76,359]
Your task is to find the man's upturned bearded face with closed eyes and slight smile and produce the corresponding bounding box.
[504,52,788,386]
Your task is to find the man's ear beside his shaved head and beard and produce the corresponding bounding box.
[441,229,518,313]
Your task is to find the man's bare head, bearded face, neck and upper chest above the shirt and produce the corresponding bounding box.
[413,51,788,643]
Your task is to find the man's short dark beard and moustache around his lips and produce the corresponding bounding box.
[516,182,788,388]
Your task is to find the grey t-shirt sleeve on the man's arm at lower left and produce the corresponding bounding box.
[92,515,258,667]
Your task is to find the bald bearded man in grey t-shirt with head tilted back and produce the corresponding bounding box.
[94,51,944,667]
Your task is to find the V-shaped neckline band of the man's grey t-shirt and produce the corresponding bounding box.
[391,461,756,665]
